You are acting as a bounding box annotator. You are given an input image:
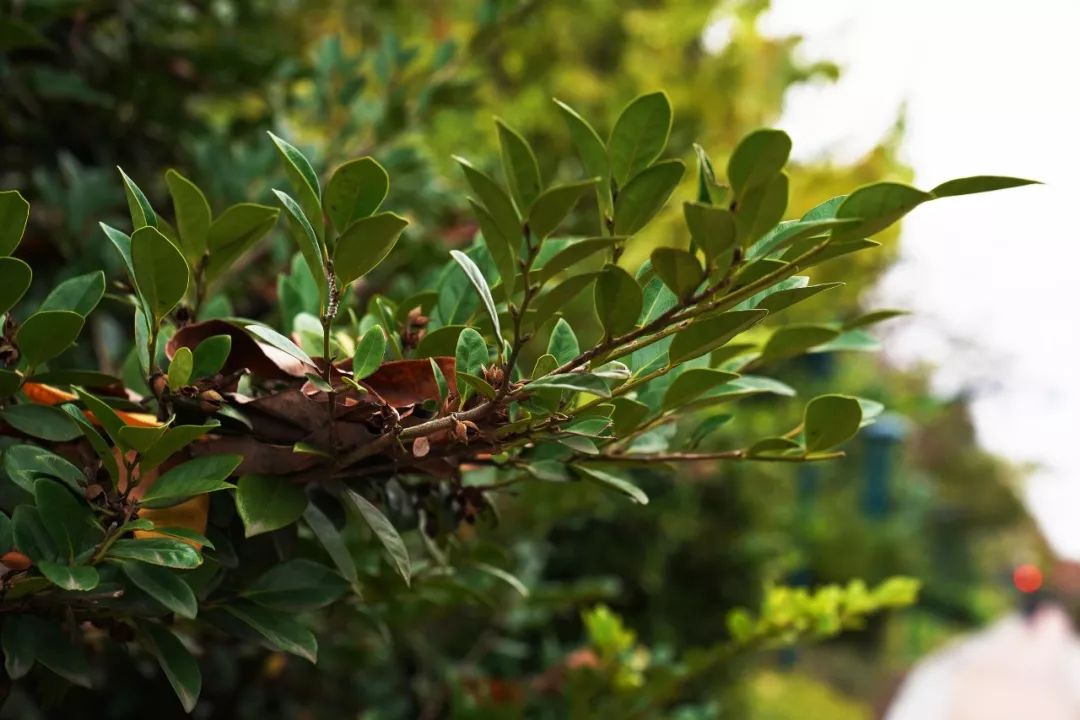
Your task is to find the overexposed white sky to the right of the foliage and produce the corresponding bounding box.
[766,0,1080,559]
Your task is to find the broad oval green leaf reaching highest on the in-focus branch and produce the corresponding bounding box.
[607,93,672,187]
